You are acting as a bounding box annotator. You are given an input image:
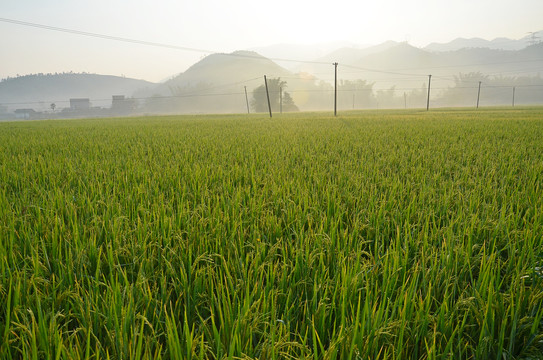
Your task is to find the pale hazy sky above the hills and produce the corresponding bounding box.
[0,0,543,81]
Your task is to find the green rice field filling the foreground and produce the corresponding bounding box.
[0,108,543,359]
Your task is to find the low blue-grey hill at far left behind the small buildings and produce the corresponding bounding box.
[0,73,155,111]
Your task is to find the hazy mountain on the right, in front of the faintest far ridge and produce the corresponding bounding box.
[309,43,543,102]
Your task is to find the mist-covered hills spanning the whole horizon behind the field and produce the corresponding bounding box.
[0,39,543,118]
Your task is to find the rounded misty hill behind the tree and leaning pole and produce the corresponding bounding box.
[142,51,346,113]
